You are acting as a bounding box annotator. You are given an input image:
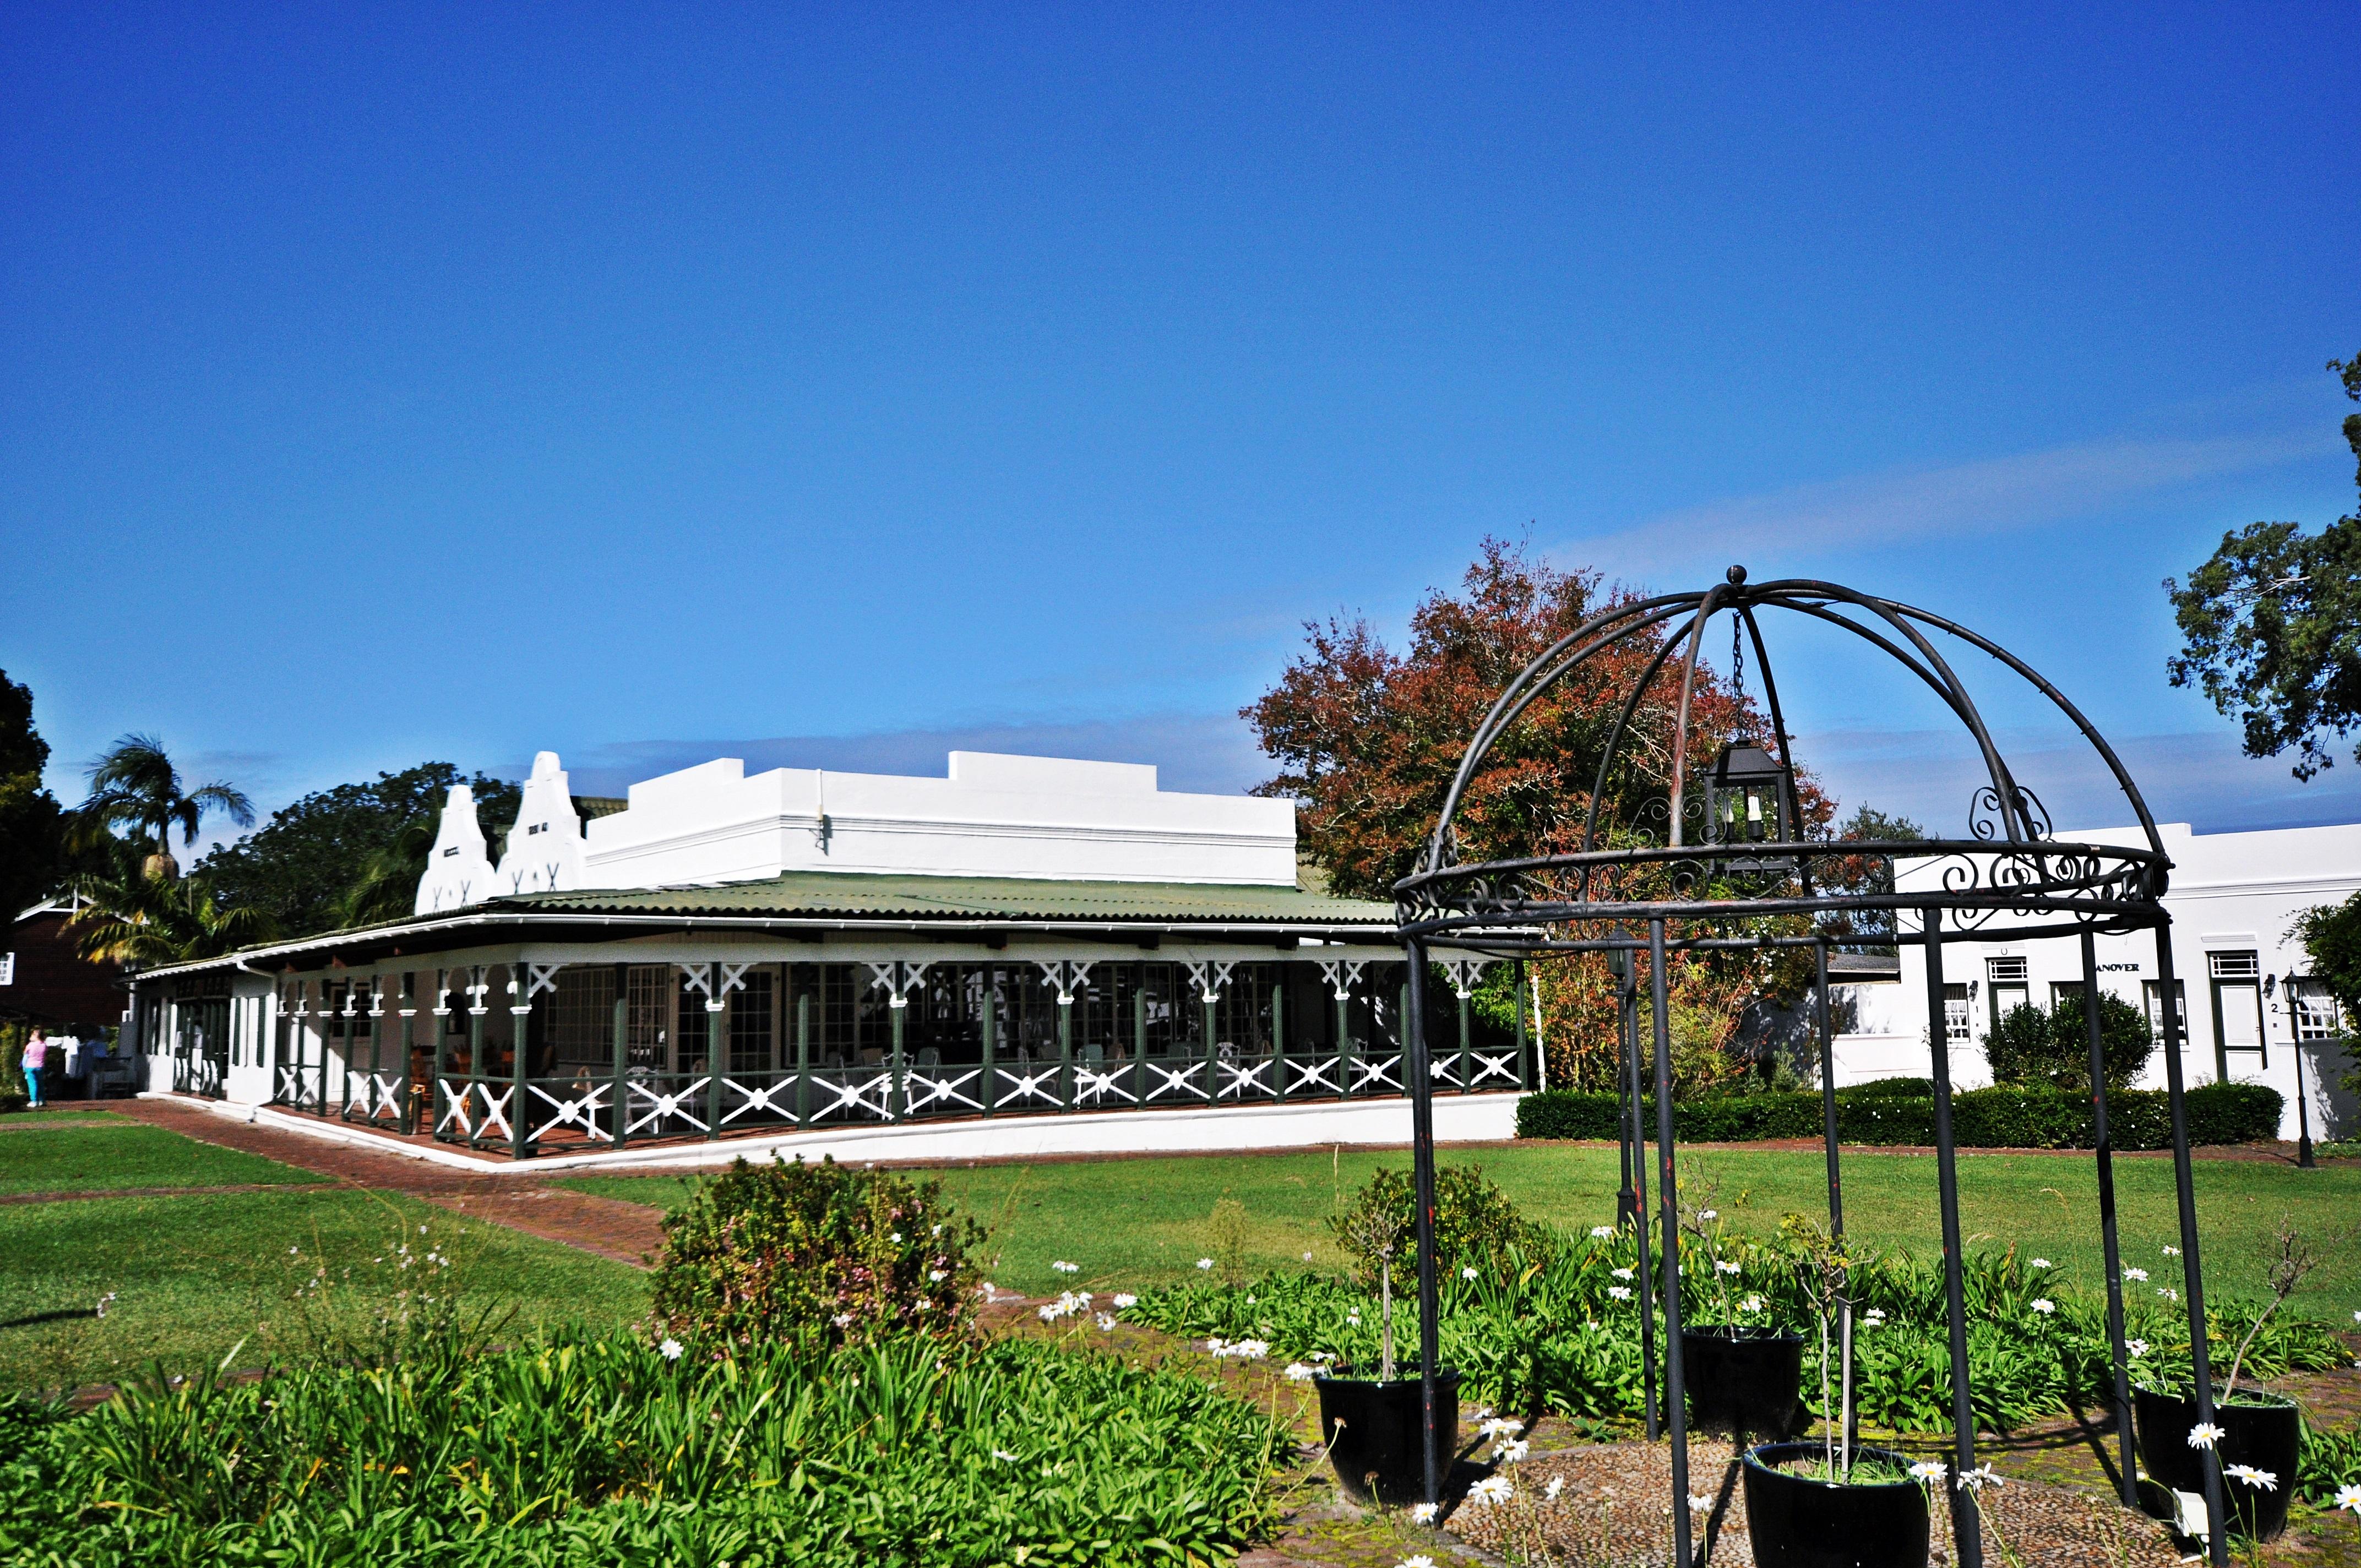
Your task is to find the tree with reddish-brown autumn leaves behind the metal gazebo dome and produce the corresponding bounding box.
[1242,538,1830,1088]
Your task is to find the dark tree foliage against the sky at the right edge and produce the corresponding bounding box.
[2165,354,2361,779]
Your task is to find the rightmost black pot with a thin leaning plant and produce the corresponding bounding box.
[2132,1221,2321,1540]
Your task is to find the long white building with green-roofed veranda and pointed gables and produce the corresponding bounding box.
[132,751,1537,1157]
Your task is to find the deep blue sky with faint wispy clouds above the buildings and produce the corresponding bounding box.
[0,5,2361,845]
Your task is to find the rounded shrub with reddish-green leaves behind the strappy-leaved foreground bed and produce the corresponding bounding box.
[651,1157,982,1346]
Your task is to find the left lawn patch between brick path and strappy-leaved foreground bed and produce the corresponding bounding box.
[0,1190,647,1391]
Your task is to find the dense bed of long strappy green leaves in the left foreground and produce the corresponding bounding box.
[0,1337,1289,1568]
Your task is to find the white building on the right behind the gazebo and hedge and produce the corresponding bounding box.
[1835,822,2361,1138]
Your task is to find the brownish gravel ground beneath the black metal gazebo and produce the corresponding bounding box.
[1450,1443,2182,1568]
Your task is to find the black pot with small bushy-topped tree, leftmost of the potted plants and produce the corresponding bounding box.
[1313,1183,1459,1504]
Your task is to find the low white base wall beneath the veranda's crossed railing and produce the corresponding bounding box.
[156,1093,1518,1176]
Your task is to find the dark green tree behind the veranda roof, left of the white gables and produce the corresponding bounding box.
[196,763,519,938]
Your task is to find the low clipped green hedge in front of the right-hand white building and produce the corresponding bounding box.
[1516,1084,2281,1148]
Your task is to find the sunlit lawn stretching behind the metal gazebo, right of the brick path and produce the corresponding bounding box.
[567,1143,2361,1322]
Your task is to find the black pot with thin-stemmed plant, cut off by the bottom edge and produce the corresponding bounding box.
[1743,1214,1943,1568]
